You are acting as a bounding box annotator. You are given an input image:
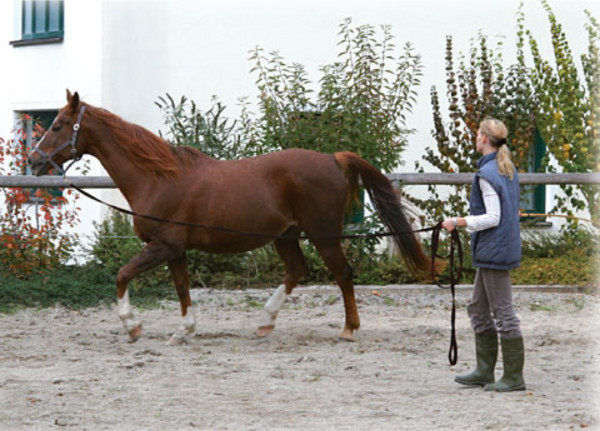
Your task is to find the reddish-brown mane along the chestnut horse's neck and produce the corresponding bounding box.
[88,107,204,177]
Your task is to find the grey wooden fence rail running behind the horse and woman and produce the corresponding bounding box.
[0,173,600,189]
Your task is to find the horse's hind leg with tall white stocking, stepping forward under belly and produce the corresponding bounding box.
[256,232,307,337]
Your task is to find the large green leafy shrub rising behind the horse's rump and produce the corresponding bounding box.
[251,19,422,172]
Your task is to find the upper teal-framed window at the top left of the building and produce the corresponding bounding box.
[11,0,64,46]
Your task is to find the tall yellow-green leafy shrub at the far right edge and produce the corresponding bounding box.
[521,0,600,220]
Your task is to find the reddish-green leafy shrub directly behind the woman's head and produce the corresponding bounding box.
[412,33,536,222]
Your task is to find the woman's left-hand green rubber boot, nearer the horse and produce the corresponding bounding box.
[454,330,498,386]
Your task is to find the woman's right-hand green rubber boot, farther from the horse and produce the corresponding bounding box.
[484,337,525,392]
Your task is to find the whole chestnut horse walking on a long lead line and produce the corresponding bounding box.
[29,91,430,344]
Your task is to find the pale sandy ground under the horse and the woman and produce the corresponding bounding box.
[0,288,600,430]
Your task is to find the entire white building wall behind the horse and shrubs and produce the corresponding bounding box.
[0,0,600,260]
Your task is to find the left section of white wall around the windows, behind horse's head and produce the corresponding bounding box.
[0,0,110,260]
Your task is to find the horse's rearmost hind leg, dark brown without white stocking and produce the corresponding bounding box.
[313,240,360,341]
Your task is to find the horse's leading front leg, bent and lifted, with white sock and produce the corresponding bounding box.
[117,242,172,341]
